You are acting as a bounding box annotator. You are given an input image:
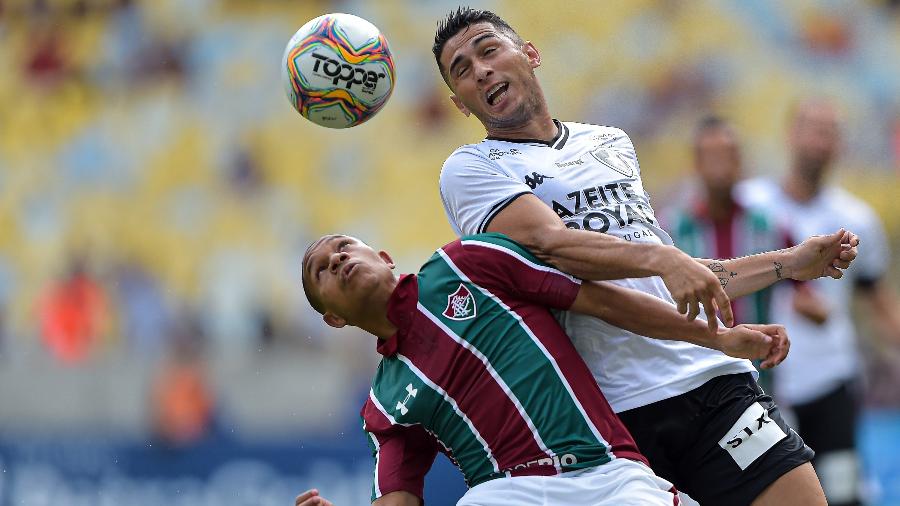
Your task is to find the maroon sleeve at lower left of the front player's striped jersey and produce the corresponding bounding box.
[360,397,438,501]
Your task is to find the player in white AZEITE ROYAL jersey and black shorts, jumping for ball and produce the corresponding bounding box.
[433,9,858,505]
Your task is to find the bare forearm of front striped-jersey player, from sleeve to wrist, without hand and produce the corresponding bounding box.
[570,281,719,349]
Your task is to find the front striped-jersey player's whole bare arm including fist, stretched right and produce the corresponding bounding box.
[569,281,790,369]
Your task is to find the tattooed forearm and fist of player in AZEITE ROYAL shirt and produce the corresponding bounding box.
[697,229,859,298]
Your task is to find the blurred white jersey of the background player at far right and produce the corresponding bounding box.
[735,179,890,404]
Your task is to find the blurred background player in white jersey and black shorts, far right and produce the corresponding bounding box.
[736,99,900,506]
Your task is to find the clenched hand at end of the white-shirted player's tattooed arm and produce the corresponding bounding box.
[785,228,859,281]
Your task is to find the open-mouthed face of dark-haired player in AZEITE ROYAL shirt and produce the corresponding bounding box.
[441,23,541,129]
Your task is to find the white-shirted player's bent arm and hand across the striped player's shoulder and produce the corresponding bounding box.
[487,194,734,329]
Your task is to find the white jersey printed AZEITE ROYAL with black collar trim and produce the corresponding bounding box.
[441,122,755,412]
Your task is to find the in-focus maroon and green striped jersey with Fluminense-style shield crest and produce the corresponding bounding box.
[361,234,645,500]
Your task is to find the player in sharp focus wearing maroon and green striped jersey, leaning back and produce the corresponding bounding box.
[296,234,789,506]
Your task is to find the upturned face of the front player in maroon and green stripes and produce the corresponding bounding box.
[303,235,394,327]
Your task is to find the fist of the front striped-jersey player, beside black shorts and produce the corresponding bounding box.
[715,324,791,369]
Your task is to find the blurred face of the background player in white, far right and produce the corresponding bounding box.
[790,102,840,178]
